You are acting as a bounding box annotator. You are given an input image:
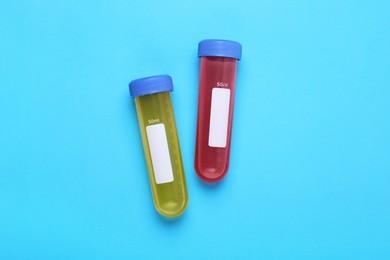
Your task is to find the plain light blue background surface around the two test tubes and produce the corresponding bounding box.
[0,0,390,259]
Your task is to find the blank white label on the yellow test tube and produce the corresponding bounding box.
[146,124,173,184]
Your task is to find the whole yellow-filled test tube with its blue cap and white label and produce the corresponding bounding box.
[129,75,188,217]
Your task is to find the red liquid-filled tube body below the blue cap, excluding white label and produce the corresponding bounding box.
[195,56,237,182]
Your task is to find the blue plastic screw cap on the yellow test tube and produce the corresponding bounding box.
[129,75,173,97]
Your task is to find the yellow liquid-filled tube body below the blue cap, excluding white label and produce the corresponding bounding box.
[135,92,188,217]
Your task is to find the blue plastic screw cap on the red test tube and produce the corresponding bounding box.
[198,40,242,60]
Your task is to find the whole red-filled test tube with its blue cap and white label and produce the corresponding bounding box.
[195,40,242,182]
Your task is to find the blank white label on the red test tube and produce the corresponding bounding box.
[209,88,230,148]
